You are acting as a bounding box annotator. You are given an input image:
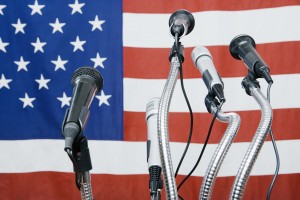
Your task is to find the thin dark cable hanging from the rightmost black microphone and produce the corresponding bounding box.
[266,83,280,200]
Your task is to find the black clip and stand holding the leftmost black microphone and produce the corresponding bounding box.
[62,106,93,200]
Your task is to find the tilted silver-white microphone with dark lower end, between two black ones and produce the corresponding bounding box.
[192,46,225,102]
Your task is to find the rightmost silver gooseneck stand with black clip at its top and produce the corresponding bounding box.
[230,71,273,199]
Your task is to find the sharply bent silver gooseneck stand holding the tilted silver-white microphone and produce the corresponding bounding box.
[199,92,241,200]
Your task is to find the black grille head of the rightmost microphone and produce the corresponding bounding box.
[229,34,256,60]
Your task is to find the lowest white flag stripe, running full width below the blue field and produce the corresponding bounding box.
[0,140,300,176]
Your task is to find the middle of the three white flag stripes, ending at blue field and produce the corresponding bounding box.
[124,73,300,113]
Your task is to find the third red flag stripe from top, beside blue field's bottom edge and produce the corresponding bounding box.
[124,108,300,144]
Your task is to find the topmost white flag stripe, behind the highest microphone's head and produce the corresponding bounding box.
[123,6,300,48]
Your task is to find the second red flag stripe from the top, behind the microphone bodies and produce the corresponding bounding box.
[123,41,300,79]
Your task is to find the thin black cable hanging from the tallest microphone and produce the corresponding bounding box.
[175,33,194,178]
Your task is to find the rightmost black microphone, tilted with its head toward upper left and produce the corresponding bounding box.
[229,35,273,84]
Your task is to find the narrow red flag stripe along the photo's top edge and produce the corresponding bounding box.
[123,0,300,13]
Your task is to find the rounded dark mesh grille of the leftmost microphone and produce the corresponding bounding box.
[71,67,103,94]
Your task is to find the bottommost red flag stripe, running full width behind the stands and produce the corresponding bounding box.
[0,172,300,200]
